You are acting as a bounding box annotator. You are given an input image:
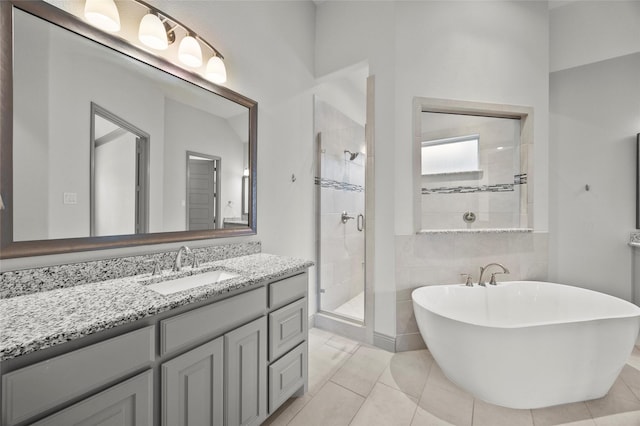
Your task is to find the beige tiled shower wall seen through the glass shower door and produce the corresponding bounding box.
[315,100,366,311]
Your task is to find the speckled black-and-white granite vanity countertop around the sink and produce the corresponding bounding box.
[0,253,313,361]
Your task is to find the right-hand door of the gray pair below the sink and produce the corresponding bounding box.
[224,317,267,426]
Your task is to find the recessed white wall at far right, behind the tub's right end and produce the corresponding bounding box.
[549,53,640,300]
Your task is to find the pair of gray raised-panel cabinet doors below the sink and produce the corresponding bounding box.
[161,317,267,426]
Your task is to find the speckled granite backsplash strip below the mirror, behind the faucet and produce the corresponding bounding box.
[0,241,262,299]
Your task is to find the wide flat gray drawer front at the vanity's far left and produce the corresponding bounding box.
[2,326,155,426]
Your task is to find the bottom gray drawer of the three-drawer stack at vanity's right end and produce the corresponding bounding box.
[269,342,307,413]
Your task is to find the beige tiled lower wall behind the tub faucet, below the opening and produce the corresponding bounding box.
[395,231,548,351]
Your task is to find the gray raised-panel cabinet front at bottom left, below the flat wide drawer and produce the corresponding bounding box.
[32,370,153,426]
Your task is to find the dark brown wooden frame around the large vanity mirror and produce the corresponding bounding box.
[0,0,258,259]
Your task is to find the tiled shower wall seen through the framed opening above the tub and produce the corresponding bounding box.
[421,113,526,229]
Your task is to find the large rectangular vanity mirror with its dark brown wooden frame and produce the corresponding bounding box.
[0,1,257,258]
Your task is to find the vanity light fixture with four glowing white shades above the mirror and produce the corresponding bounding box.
[84,0,227,84]
